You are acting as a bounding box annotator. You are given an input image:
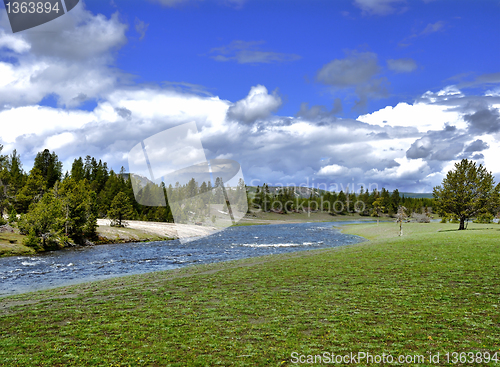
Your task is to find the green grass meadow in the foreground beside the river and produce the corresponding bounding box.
[0,223,500,366]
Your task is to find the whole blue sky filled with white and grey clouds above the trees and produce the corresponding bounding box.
[0,0,500,192]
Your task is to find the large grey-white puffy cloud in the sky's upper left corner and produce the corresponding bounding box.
[0,3,127,108]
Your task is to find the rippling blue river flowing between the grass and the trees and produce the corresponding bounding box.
[0,222,368,296]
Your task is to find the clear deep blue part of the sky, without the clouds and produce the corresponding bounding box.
[87,0,500,118]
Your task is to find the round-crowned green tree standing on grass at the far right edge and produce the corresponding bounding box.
[433,159,500,230]
